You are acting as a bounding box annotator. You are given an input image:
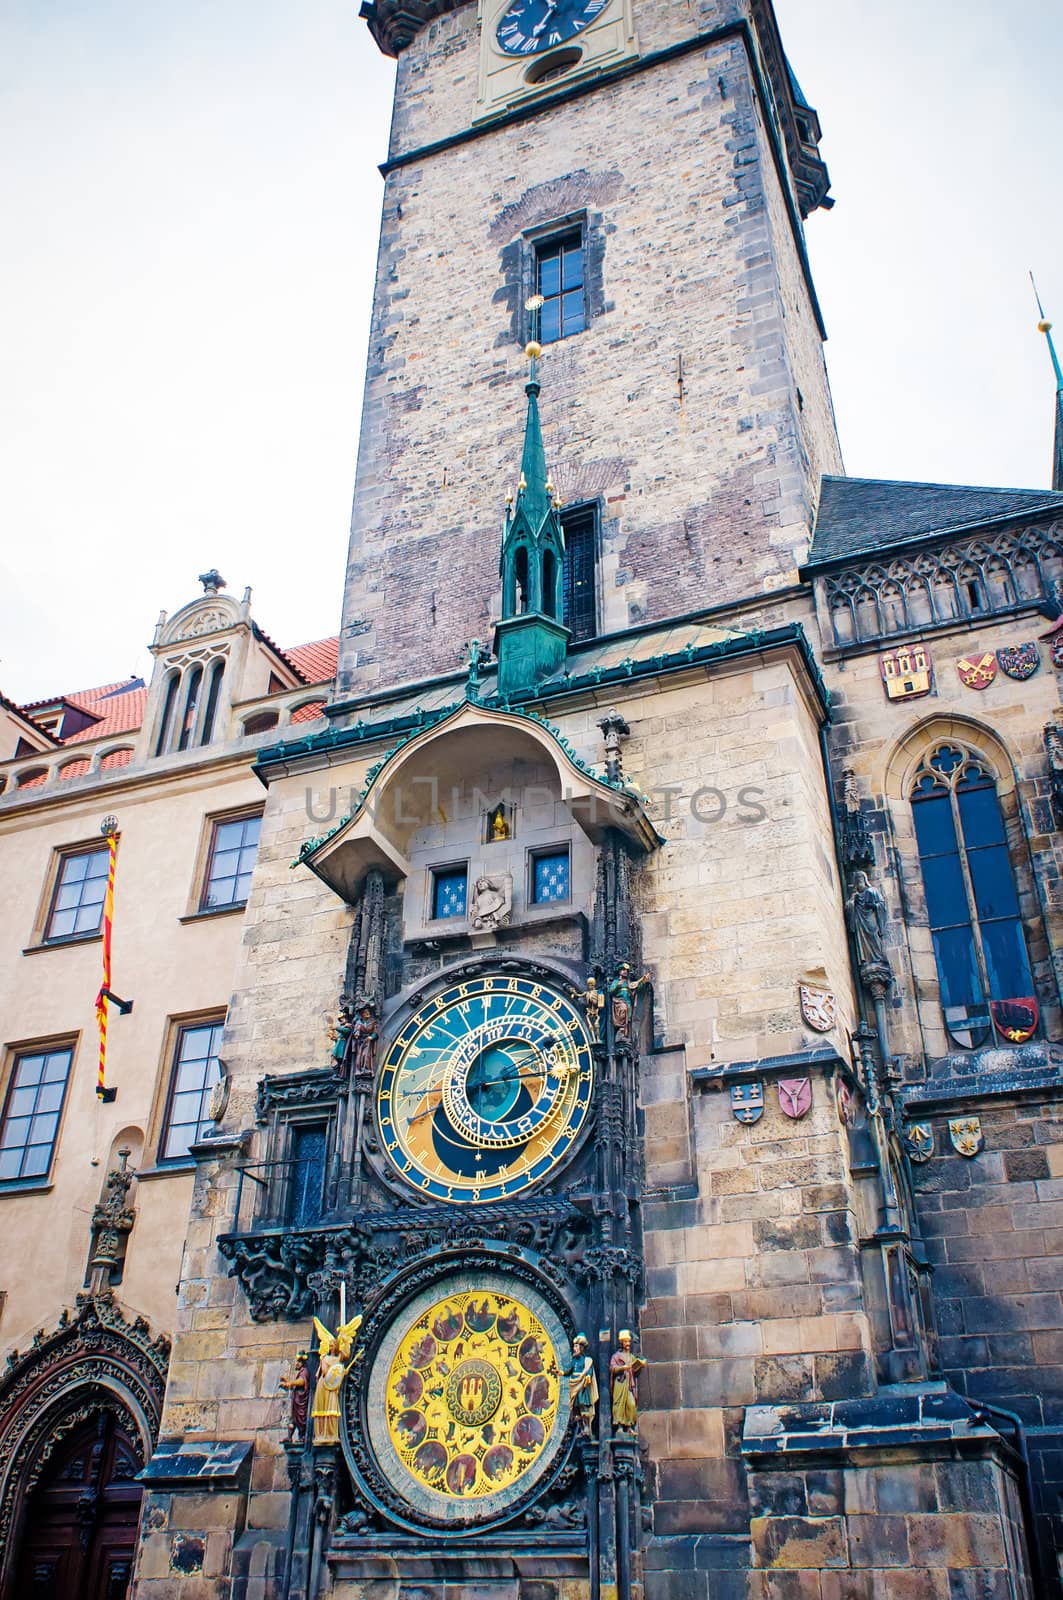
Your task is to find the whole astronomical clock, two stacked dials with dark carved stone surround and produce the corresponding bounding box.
[221,707,652,1581]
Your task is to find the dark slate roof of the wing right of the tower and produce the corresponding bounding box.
[807,477,1063,566]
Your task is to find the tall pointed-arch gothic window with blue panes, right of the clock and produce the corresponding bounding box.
[911,744,1037,1050]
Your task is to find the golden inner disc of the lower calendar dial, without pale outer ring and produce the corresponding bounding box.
[384,1288,564,1501]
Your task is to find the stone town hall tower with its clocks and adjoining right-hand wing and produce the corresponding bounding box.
[112,0,1063,1600]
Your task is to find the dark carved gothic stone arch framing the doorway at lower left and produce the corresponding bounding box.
[0,1296,170,1600]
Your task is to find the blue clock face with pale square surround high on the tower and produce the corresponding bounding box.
[479,0,639,120]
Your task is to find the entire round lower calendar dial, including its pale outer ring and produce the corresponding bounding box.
[358,1272,572,1523]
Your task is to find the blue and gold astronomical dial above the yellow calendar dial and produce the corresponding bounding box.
[376,976,594,1202]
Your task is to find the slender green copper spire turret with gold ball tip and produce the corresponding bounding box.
[495,296,568,698]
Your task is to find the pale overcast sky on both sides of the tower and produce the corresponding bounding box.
[0,0,1063,701]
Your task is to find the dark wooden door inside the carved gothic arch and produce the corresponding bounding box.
[16,1406,142,1600]
